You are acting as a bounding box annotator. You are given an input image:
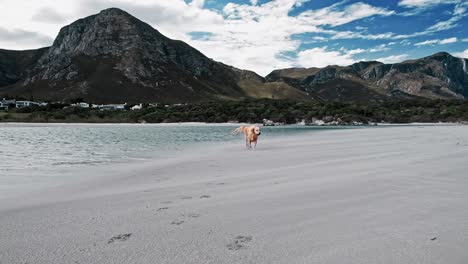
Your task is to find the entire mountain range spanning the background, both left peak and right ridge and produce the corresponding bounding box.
[0,8,468,103]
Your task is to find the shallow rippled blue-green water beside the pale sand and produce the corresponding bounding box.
[0,124,348,196]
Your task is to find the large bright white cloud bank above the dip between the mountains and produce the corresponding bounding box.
[144,0,392,75]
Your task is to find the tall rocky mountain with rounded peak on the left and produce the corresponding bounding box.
[0,8,306,103]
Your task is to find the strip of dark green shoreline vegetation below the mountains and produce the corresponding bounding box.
[0,99,468,124]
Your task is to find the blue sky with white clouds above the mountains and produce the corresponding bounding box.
[0,0,468,76]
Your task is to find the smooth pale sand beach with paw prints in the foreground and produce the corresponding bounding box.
[0,126,468,264]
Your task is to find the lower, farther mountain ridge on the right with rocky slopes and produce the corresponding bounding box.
[266,52,468,101]
